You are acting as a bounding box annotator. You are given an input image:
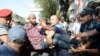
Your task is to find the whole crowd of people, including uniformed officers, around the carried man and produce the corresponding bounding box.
[0,6,100,56]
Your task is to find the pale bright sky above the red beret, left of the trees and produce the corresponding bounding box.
[0,0,34,18]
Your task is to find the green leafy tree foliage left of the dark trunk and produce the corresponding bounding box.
[37,0,58,18]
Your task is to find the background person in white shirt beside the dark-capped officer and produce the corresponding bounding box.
[68,15,81,39]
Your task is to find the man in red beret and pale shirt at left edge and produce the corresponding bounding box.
[0,9,13,45]
